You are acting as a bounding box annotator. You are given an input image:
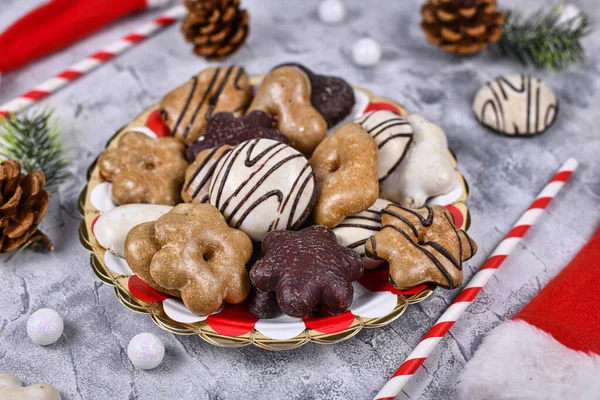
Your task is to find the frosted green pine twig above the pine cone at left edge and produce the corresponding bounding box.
[0,110,69,192]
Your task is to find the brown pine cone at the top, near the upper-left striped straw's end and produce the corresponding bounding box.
[181,0,249,60]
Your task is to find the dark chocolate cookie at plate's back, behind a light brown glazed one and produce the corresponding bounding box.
[274,63,355,128]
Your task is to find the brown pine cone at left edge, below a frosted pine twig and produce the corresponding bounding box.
[0,160,49,253]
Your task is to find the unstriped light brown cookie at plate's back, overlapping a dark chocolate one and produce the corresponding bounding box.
[248,67,327,154]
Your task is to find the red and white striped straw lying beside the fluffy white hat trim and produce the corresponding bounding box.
[375,158,578,400]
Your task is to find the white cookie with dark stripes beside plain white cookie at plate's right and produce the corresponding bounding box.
[356,110,413,182]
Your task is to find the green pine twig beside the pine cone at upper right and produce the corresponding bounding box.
[498,4,591,70]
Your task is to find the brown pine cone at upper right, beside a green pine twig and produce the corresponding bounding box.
[421,0,505,54]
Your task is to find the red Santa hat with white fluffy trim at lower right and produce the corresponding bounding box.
[457,229,600,400]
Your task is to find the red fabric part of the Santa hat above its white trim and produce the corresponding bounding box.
[514,229,600,354]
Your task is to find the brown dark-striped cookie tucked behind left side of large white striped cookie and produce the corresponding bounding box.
[181,144,233,203]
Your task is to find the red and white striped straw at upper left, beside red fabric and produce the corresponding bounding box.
[0,4,186,116]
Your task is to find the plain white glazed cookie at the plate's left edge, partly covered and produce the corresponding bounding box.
[94,204,173,257]
